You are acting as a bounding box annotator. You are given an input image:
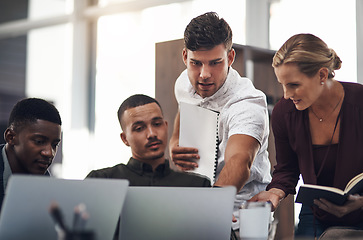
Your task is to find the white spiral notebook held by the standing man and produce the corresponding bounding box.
[179,102,219,183]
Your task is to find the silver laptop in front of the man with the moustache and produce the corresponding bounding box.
[119,187,236,240]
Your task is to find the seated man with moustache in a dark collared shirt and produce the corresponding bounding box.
[87,94,210,187]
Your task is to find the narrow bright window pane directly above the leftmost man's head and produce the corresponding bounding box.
[25,24,72,176]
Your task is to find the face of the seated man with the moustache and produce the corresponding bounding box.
[121,102,168,166]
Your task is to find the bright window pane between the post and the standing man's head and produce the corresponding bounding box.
[92,0,245,171]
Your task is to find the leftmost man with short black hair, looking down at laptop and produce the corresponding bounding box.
[0,98,62,208]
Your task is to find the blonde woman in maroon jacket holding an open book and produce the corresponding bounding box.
[251,34,363,237]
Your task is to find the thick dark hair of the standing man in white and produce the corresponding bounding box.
[184,12,232,51]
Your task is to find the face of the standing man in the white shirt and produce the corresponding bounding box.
[183,44,235,98]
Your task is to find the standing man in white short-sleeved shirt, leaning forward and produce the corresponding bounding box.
[169,12,271,229]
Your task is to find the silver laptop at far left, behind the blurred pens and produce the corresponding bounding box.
[0,175,129,240]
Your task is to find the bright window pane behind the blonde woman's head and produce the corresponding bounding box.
[270,0,357,82]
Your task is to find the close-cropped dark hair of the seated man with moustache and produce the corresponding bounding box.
[117,94,161,129]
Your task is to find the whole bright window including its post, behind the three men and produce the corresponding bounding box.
[0,0,245,178]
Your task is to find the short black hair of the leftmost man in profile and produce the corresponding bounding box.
[8,98,62,130]
